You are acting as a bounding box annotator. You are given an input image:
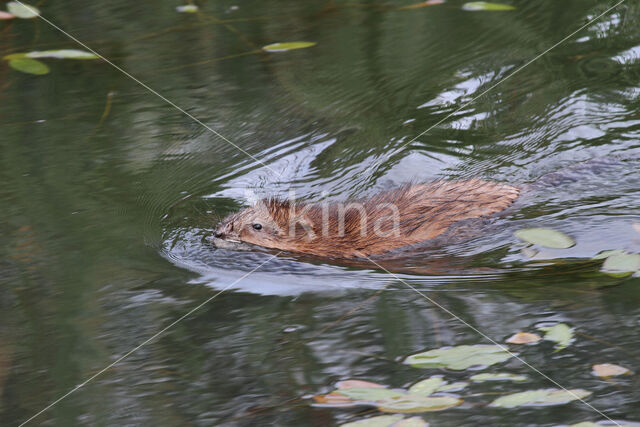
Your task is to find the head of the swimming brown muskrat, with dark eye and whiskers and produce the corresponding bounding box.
[213,200,298,249]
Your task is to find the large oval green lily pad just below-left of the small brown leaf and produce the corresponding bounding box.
[404,344,513,371]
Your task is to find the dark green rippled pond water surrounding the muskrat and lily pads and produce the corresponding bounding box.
[0,0,640,426]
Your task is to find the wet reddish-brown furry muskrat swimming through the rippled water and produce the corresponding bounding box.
[213,179,520,258]
